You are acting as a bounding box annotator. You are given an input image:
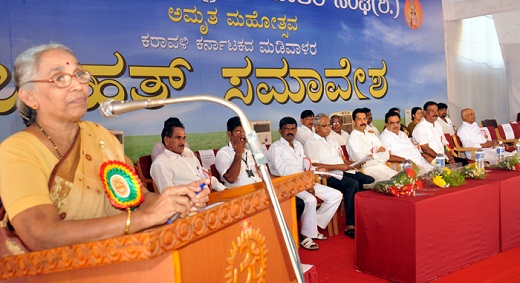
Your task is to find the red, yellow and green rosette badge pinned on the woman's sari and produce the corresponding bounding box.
[99,160,144,210]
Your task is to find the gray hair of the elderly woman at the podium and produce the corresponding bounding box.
[14,43,74,127]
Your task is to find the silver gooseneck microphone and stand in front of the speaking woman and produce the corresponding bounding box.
[100,95,305,283]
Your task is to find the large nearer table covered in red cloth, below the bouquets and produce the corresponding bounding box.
[355,180,500,282]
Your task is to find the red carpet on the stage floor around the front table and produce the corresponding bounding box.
[299,218,520,283]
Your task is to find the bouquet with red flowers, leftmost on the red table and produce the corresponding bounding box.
[371,168,423,197]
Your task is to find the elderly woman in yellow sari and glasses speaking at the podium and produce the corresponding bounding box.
[0,44,209,257]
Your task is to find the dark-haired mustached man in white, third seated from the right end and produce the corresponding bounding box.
[412,101,468,165]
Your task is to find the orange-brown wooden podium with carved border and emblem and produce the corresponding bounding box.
[0,171,314,283]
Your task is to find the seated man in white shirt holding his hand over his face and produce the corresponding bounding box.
[215,116,262,188]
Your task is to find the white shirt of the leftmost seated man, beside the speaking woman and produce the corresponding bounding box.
[150,148,226,192]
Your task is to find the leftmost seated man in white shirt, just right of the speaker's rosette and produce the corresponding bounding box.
[150,119,226,192]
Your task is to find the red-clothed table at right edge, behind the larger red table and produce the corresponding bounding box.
[486,170,520,252]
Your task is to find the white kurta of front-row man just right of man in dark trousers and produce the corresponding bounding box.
[347,130,397,182]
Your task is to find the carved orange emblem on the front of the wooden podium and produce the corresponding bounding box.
[226,218,268,283]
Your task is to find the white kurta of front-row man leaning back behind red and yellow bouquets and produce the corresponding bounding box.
[379,128,434,174]
